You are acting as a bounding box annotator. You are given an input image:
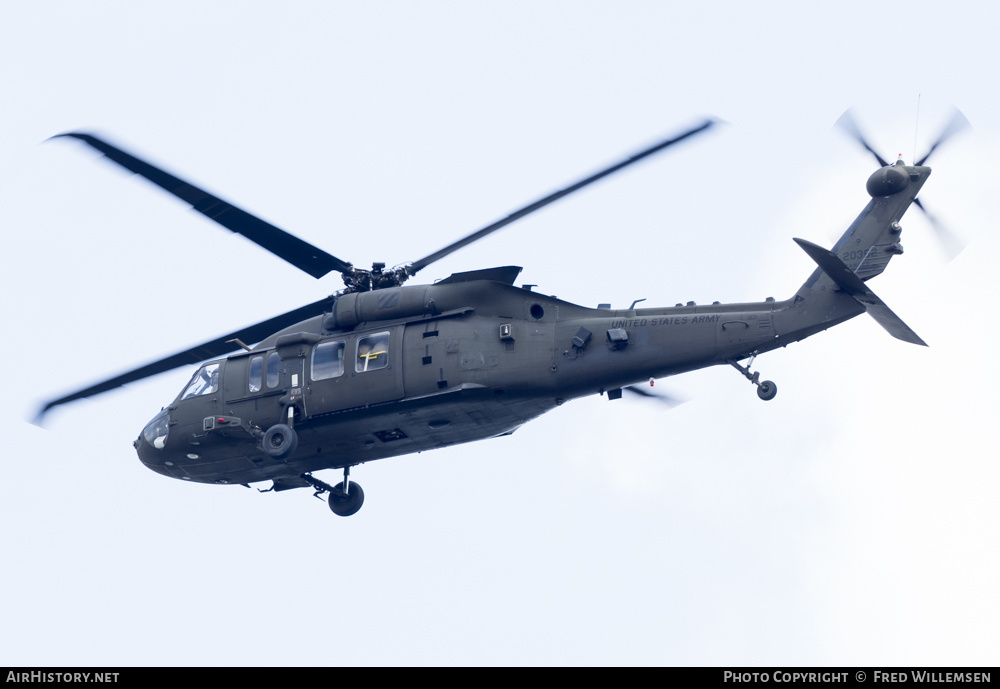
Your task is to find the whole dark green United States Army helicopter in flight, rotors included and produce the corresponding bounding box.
[40,113,965,516]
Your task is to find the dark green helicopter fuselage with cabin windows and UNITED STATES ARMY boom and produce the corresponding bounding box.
[135,268,844,485]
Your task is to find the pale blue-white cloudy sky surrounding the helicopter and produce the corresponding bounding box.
[0,1,1000,665]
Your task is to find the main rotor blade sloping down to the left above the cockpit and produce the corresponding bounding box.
[35,297,332,424]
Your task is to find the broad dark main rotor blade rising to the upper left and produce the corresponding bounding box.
[52,132,351,278]
